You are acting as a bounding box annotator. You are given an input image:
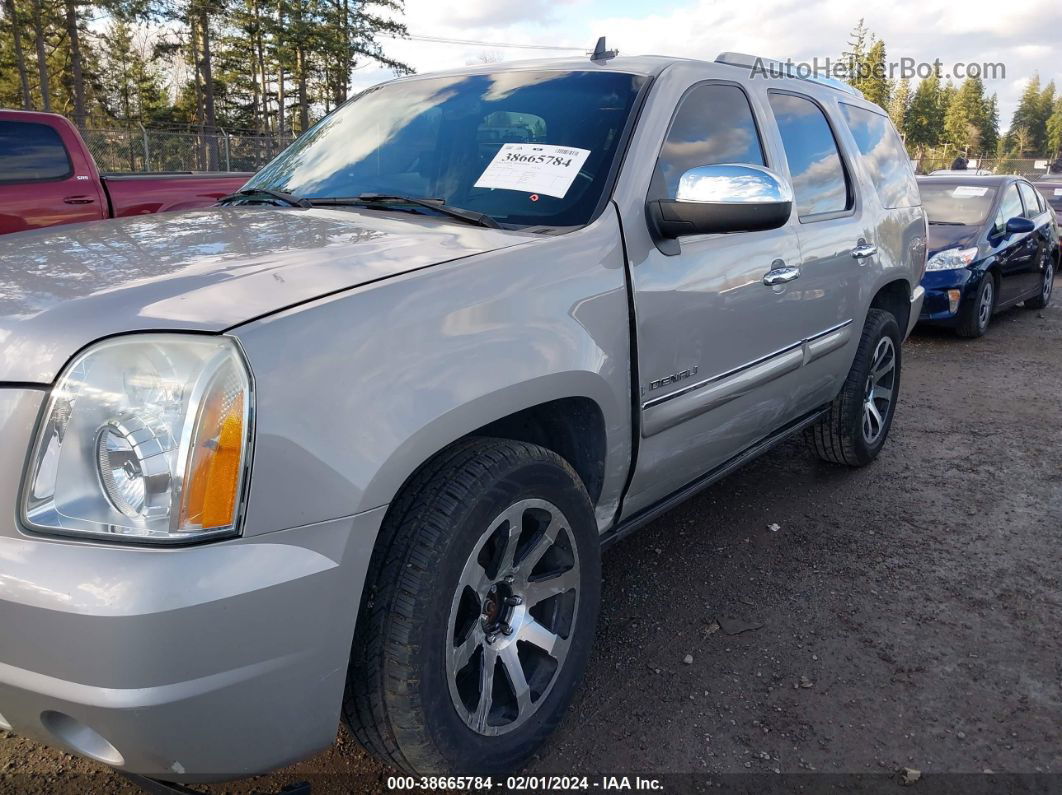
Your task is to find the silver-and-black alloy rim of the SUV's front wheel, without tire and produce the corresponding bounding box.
[446,500,581,737]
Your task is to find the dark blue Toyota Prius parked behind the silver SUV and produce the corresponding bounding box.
[919,173,1060,336]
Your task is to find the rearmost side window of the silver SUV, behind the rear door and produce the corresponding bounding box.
[841,103,919,209]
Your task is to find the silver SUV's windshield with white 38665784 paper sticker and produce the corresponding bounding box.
[245,70,644,226]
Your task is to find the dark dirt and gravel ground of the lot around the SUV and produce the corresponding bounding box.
[0,281,1062,792]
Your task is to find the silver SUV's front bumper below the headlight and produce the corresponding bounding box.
[0,388,384,781]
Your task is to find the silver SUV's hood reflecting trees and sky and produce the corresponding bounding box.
[0,202,534,383]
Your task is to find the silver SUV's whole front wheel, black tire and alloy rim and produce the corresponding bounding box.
[344,438,600,775]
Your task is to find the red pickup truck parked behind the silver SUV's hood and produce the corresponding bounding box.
[0,110,251,235]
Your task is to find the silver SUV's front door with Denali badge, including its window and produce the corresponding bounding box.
[624,82,806,515]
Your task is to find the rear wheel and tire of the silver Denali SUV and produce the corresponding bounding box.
[807,309,901,467]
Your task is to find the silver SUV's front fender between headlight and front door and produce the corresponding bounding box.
[233,207,631,534]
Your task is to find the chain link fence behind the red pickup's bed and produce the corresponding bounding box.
[82,128,293,173]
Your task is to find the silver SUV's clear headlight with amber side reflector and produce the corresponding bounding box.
[22,334,252,543]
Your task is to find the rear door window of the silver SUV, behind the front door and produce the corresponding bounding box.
[770,91,852,220]
